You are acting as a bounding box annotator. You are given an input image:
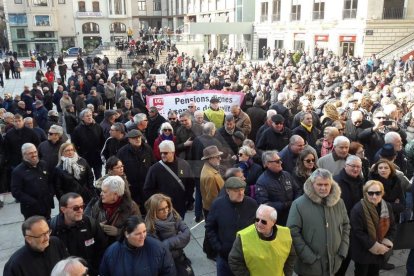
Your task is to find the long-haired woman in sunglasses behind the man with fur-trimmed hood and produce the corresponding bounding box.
[292,148,318,190]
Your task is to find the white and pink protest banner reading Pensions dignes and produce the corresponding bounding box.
[146,90,244,118]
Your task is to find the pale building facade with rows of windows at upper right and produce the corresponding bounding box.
[253,0,414,58]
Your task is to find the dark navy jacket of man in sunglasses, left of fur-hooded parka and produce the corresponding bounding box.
[255,169,301,226]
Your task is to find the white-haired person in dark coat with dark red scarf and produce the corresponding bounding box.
[85,176,141,243]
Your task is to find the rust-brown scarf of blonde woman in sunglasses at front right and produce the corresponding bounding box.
[361,198,390,242]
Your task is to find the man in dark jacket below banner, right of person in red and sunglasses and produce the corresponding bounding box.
[175,111,202,160]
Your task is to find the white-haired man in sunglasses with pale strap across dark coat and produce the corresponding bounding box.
[144,140,194,219]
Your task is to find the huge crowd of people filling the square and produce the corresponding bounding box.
[0,45,414,276]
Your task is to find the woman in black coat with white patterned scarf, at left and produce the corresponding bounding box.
[54,143,95,204]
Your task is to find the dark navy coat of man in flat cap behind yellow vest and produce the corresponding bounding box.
[205,194,258,260]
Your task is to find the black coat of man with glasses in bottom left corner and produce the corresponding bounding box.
[3,237,69,276]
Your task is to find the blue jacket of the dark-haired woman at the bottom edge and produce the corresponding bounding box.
[99,236,176,276]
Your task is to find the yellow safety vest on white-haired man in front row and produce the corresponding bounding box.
[237,224,292,276]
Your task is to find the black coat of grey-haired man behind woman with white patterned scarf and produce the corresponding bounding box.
[72,122,105,167]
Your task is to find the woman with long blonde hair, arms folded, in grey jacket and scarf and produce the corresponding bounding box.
[145,194,192,275]
